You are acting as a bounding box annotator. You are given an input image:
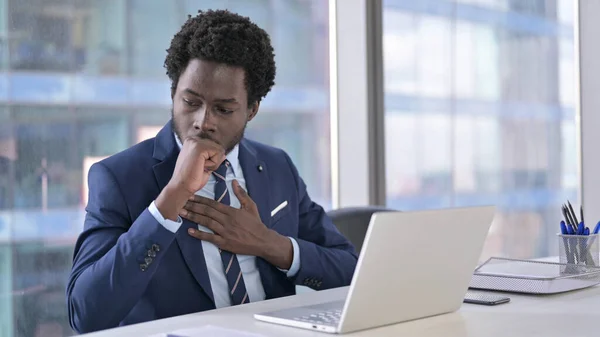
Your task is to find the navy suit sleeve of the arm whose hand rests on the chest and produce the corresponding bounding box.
[286,154,358,290]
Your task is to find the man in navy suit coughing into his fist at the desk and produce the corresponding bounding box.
[67,11,357,332]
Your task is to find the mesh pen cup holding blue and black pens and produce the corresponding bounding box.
[558,234,600,272]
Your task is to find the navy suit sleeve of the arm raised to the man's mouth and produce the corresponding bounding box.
[67,163,175,333]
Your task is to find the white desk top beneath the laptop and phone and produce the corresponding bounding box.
[81,286,600,337]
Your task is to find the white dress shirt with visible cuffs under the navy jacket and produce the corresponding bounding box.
[148,136,300,308]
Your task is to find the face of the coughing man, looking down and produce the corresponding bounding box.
[172,59,258,153]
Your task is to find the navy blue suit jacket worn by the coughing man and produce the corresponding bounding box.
[67,123,357,333]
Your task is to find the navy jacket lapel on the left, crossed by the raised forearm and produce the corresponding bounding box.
[152,122,215,305]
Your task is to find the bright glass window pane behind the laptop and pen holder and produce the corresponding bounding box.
[383,0,579,258]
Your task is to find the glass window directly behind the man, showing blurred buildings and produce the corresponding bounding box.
[0,0,331,337]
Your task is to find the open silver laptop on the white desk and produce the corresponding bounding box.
[254,206,495,334]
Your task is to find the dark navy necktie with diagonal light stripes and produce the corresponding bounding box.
[213,160,250,305]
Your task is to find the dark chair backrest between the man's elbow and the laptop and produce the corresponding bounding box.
[327,206,395,253]
